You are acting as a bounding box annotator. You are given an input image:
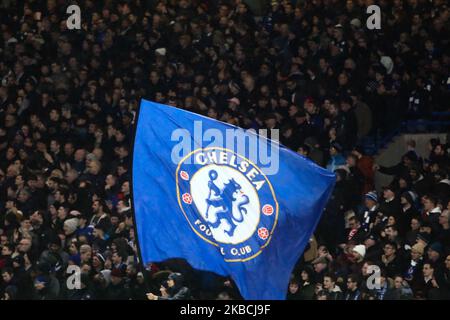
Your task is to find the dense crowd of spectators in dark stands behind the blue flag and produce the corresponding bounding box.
[0,0,450,300]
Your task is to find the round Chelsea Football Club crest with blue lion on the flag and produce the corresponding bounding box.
[176,147,278,262]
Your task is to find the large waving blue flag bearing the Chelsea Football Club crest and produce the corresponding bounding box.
[132,100,335,300]
